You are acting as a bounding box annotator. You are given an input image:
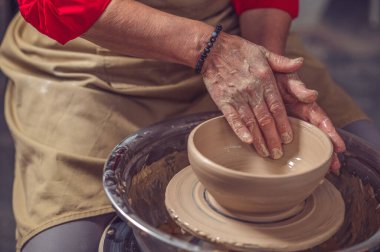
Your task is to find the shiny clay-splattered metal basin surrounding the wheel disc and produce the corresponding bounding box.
[104,114,380,251]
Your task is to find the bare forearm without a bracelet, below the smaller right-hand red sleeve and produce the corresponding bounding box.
[239,9,292,55]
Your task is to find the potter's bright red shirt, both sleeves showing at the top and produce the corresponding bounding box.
[18,0,299,44]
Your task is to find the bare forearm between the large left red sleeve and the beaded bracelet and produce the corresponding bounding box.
[82,0,214,67]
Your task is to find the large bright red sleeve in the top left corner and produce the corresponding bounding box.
[18,0,111,44]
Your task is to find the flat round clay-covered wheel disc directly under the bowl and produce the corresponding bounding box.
[165,166,344,251]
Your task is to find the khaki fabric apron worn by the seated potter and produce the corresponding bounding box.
[0,0,367,250]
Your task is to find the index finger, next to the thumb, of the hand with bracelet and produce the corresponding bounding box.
[264,84,293,144]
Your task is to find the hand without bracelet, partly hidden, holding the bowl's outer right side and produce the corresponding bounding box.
[275,73,346,173]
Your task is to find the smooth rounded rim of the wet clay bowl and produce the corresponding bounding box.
[187,116,334,180]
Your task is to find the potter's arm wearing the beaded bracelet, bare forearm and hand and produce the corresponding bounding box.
[84,0,302,159]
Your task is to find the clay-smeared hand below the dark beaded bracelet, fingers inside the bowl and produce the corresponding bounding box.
[202,34,303,159]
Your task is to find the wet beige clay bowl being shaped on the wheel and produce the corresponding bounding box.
[188,117,333,217]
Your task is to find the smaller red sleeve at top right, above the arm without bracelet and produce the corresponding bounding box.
[231,0,299,18]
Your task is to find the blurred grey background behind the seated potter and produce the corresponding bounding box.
[0,0,380,252]
